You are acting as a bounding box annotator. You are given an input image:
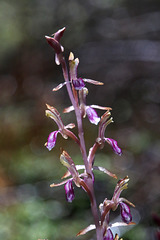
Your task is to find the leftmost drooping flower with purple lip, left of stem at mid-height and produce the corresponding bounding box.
[45,104,79,151]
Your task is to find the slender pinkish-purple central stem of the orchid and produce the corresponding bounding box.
[60,56,102,240]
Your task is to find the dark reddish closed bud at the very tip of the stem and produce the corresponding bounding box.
[45,28,65,65]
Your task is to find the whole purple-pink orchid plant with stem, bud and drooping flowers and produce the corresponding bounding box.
[45,28,134,240]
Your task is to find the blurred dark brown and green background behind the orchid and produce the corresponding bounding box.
[0,0,160,240]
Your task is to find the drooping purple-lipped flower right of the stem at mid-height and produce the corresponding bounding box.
[97,110,122,155]
